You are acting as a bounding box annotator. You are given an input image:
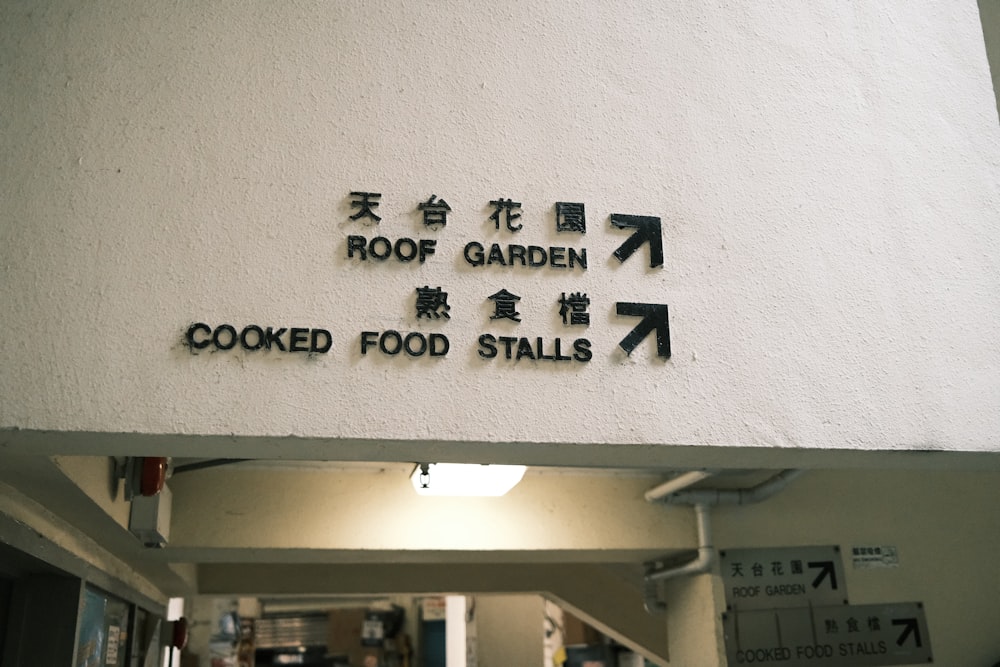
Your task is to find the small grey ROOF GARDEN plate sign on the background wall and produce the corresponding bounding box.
[719,546,847,611]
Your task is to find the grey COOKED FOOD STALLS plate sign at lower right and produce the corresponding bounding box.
[722,602,934,667]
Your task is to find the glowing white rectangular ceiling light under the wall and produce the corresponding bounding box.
[410,463,527,496]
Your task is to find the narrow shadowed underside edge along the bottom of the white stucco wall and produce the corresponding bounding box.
[0,428,1000,470]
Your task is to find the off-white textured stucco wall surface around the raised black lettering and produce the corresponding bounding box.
[0,0,1000,450]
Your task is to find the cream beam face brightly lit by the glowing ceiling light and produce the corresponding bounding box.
[160,464,694,562]
